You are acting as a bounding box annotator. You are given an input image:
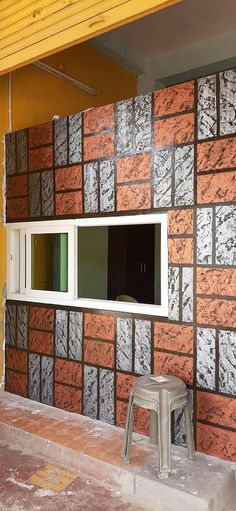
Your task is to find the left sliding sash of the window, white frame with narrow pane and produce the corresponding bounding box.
[7,222,75,301]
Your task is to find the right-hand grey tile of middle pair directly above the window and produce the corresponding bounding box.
[100,160,115,213]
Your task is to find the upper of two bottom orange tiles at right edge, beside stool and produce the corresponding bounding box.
[197,391,236,428]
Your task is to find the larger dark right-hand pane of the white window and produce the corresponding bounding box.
[78,224,161,305]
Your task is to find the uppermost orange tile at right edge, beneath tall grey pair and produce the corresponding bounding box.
[197,138,236,172]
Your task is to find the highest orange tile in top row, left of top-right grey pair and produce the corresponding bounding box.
[154,82,194,116]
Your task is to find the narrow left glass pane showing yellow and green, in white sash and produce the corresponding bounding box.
[31,233,68,292]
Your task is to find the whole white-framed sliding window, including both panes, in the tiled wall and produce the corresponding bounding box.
[7,214,168,316]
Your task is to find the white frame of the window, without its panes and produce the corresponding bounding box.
[6,213,168,317]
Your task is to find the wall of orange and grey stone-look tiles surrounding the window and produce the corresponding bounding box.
[6,70,236,461]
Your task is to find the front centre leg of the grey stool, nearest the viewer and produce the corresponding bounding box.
[158,390,171,479]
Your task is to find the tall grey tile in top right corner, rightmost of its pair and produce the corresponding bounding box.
[220,69,236,135]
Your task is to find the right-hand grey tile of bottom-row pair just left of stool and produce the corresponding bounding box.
[99,369,114,424]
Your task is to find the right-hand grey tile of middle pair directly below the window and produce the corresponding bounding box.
[69,311,83,360]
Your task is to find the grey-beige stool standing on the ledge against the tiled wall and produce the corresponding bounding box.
[122,375,195,479]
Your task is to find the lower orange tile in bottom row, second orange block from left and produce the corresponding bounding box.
[54,383,82,413]
